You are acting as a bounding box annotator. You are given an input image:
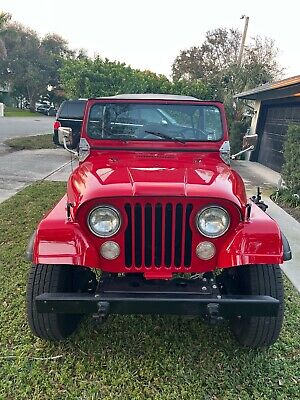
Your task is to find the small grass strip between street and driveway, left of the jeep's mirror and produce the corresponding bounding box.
[4,133,57,150]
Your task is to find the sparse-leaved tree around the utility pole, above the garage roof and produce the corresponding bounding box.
[172,28,282,119]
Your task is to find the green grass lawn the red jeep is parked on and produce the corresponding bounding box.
[0,182,300,400]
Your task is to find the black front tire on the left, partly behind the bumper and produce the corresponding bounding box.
[26,264,95,341]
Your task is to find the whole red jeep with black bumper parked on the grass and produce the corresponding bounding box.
[27,94,291,347]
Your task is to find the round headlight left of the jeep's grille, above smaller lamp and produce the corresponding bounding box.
[88,206,121,237]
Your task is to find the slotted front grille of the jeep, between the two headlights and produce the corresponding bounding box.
[125,203,193,268]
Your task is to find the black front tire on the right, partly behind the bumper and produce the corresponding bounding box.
[228,264,284,348]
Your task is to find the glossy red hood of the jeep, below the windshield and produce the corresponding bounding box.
[68,152,247,209]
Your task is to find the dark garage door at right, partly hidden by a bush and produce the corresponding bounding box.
[258,103,300,172]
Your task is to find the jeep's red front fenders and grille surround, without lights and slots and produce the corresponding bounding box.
[33,197,283,278]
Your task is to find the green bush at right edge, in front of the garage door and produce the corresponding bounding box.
[282,124,300,195]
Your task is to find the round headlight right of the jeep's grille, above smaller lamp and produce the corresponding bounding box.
[196,206,230,238]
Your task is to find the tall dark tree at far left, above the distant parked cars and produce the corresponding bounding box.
[0,23,72,111]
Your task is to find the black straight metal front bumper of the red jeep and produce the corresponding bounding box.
[36,277,279,318]
